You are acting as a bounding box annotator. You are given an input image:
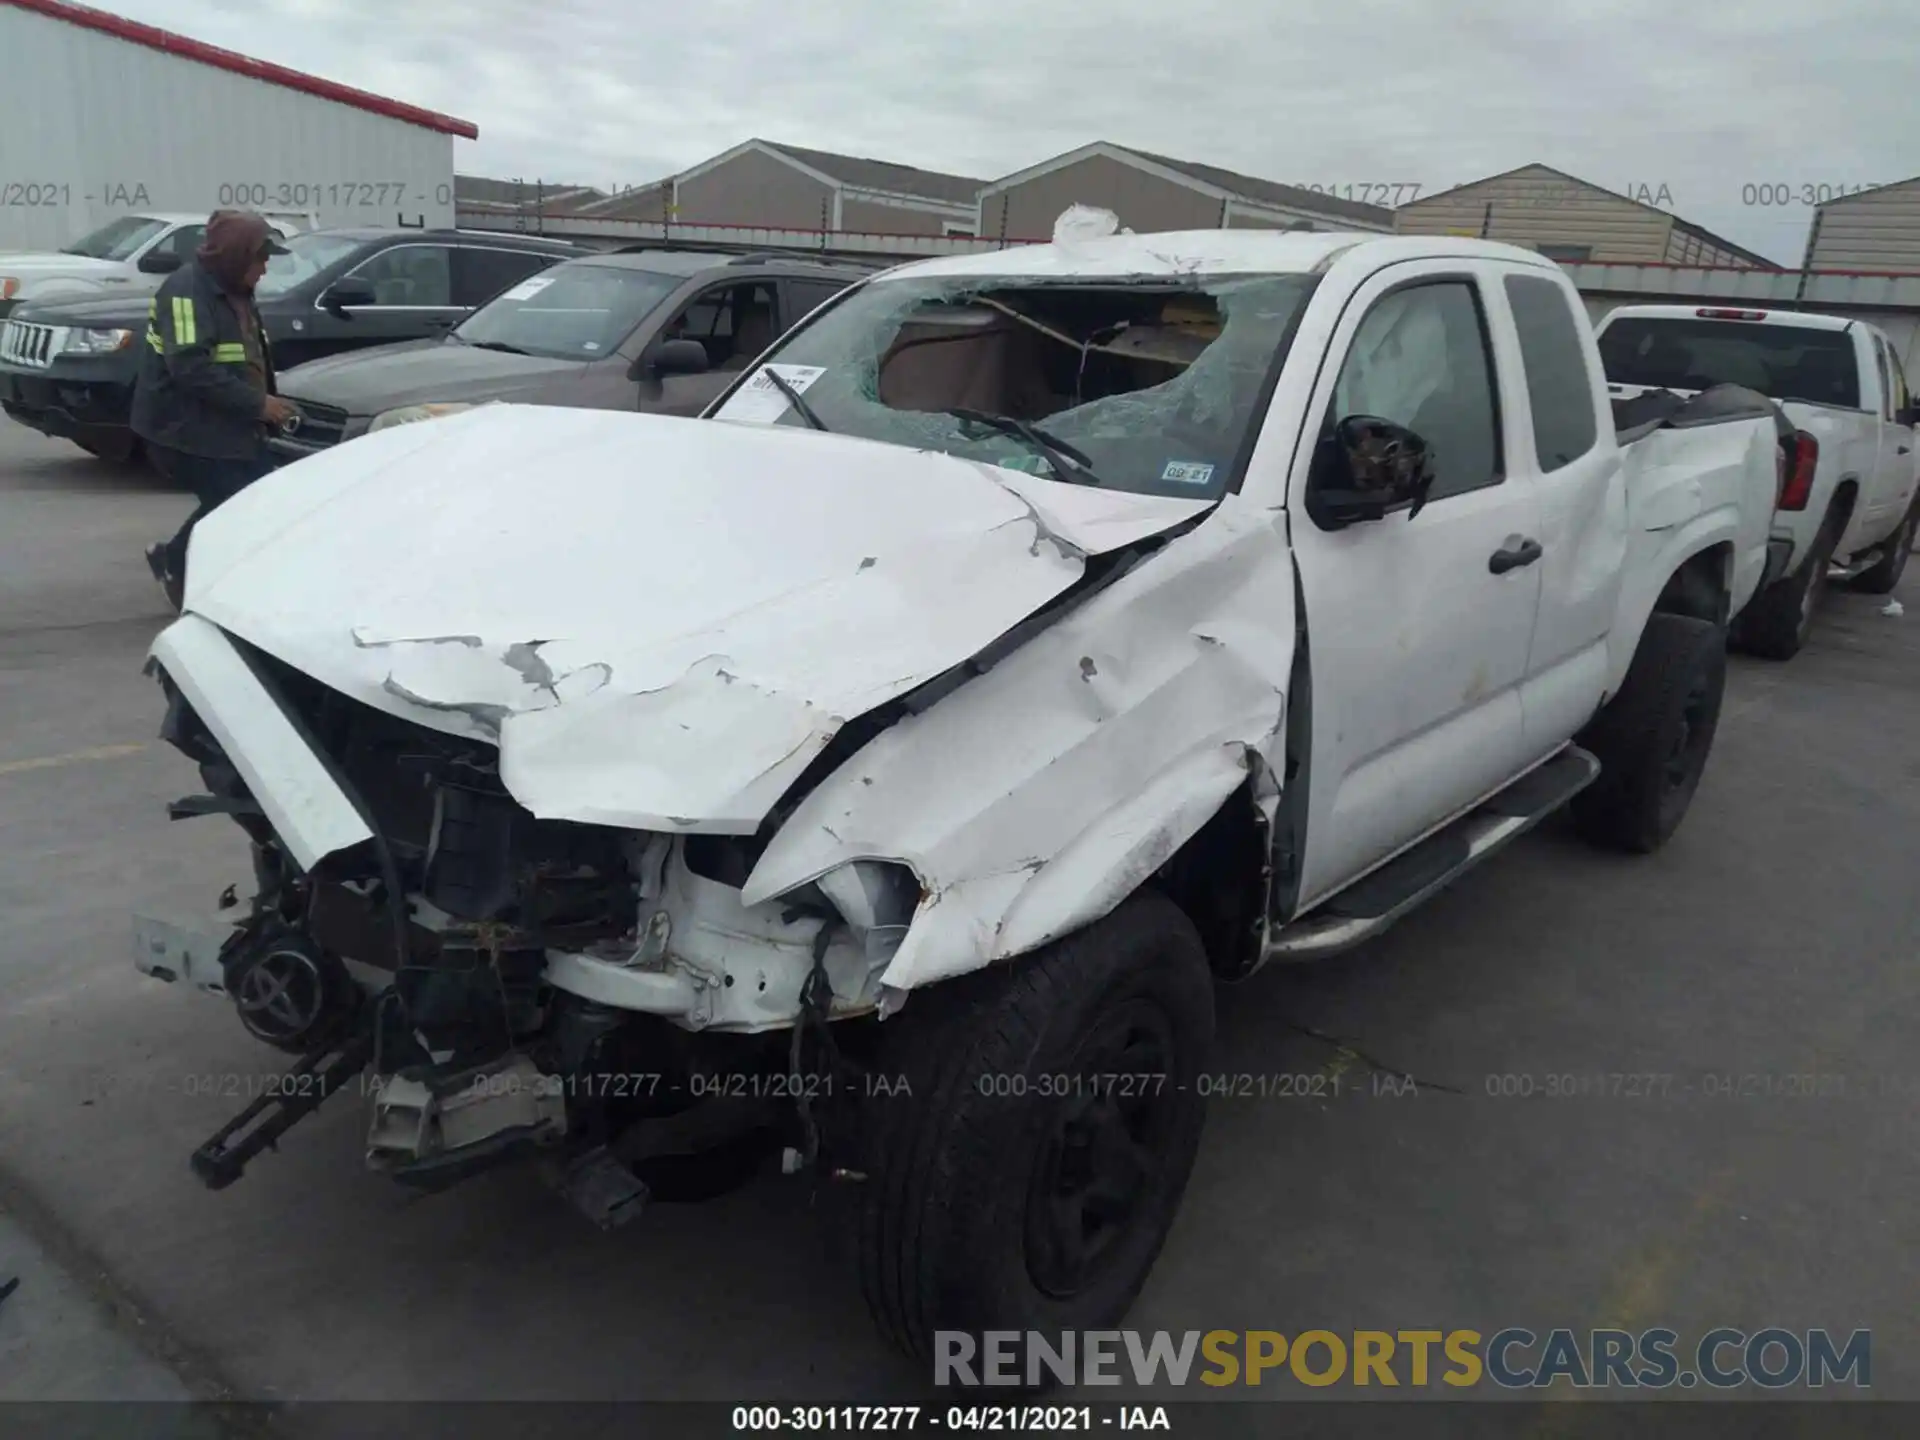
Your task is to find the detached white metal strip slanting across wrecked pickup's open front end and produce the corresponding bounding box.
[150,614,372,870]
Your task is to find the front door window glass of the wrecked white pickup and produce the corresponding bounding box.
[1327,280,1501,503]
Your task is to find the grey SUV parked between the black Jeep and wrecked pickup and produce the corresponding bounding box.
[271,250,872,459]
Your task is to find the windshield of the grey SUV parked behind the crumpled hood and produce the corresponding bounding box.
[453,265,685,361]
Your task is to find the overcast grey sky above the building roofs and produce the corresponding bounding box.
[112,0,1920,263]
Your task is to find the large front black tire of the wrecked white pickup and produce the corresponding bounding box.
[852,891,1213,1363]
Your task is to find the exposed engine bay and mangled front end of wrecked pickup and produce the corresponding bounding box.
[142,651,918,1225]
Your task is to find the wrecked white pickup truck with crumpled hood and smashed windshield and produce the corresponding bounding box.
[136,230,1782,1356]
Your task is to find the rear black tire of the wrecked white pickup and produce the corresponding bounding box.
[1571,614,1726,854]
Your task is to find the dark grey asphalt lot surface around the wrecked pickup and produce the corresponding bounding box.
[0,420,1920,1402]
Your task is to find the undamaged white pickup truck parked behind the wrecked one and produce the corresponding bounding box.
[1597,305,1920,660]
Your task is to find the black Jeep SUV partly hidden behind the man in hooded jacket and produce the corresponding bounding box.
[0,228,588,459]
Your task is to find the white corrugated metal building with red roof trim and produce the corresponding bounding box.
[0,0,478,250]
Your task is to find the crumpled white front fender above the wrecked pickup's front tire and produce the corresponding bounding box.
[743,495,1294,989]
